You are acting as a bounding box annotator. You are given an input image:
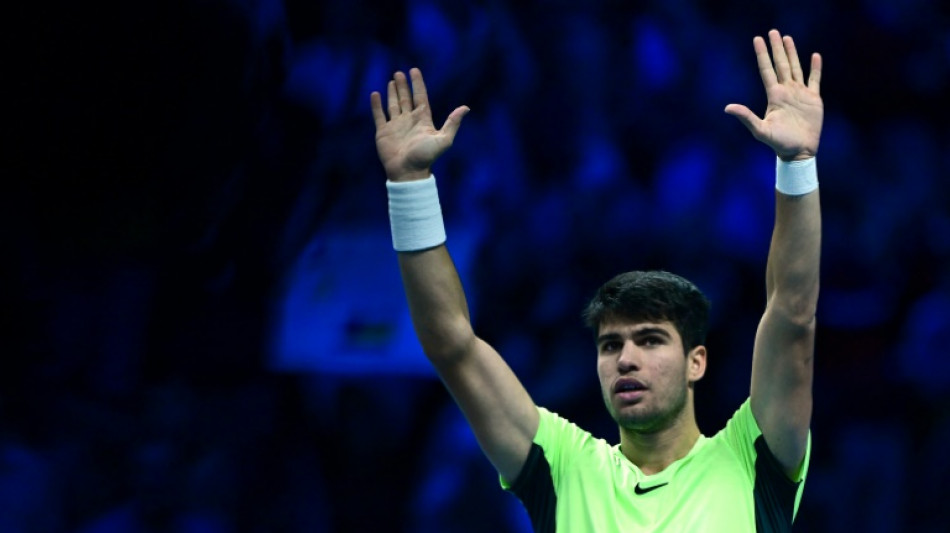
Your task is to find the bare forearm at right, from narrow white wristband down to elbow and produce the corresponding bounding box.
[766,190,821,324]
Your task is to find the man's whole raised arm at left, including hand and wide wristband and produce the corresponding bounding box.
[370,68,538,481]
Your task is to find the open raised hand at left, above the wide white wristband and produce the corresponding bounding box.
[370,68,469,181]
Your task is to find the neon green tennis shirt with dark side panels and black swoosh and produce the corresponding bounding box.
[501,399,811,533]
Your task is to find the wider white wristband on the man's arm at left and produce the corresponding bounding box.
[386,174,445,252]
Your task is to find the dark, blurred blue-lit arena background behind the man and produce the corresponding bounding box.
[7,0,950,533]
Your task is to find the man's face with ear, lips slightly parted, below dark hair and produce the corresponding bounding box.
[597,319,706,433]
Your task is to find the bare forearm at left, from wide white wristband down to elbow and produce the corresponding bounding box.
[399,245,474,359]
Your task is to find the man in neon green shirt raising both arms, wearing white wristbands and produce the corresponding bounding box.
[370,30,823,533]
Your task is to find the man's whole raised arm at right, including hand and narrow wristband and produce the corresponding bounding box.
[726,30,823,479]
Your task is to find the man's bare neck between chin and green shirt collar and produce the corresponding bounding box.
[620,402,700,475]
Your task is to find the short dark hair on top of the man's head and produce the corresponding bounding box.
[584,270,709,352]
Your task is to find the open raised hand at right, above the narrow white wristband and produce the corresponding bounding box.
[725,30,824,161]
